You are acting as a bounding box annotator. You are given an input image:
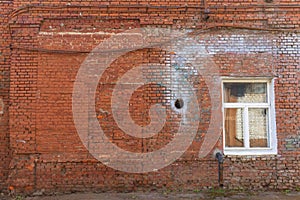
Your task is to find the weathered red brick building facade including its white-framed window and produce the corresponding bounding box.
[0,0,300,193]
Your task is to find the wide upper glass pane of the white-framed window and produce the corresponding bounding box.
[224,83,267,103]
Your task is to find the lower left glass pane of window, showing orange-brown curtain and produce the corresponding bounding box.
[224,108,244,147]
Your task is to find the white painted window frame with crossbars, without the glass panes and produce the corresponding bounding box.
[221,77,277,155]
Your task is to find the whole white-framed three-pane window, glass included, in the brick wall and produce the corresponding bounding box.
[222,78,277,155]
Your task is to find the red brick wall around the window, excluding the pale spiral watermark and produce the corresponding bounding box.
[0,0,300,193]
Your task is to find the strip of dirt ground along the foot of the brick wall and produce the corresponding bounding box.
[4,191,300,200]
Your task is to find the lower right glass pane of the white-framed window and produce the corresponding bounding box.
[248,108,269,147]
